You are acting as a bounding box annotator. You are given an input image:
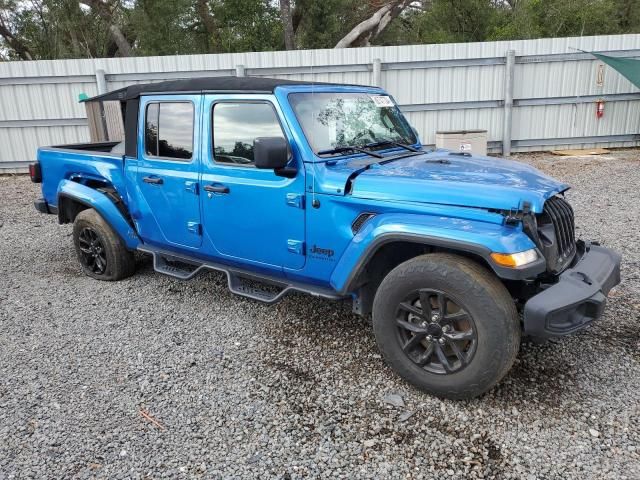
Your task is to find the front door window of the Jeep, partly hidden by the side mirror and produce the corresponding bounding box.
[213,102,284,166]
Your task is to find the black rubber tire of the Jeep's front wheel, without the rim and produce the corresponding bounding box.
[373,253,521,399]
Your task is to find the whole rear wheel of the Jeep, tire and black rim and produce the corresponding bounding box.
[73,208,136,280]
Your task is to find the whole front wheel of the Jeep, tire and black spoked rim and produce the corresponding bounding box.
[373,253,520,399]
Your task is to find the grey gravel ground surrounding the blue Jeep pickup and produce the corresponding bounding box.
[0,150,640,479]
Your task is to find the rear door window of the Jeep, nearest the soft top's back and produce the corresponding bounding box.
[144,102,193,160]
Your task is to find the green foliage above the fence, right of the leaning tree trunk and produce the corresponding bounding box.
[379,0,640,45]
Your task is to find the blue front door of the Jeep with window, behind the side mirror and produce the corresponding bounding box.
[201,95,305,269]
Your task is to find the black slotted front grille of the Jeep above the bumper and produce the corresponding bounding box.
[537,193,576,273]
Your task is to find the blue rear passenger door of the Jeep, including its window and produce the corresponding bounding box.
[136,95,202,248]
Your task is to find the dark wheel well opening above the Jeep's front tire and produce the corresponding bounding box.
[351,241,492,315]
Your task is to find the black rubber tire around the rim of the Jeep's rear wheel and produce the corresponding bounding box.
[73,208,136,281]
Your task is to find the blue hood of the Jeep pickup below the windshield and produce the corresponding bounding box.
[336,150,569,213]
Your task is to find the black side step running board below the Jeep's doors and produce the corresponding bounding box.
[138,247,344,304]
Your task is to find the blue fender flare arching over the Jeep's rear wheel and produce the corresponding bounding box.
[58,180,140,250]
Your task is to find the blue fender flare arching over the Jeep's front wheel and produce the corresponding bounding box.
[330,213,546,294]
